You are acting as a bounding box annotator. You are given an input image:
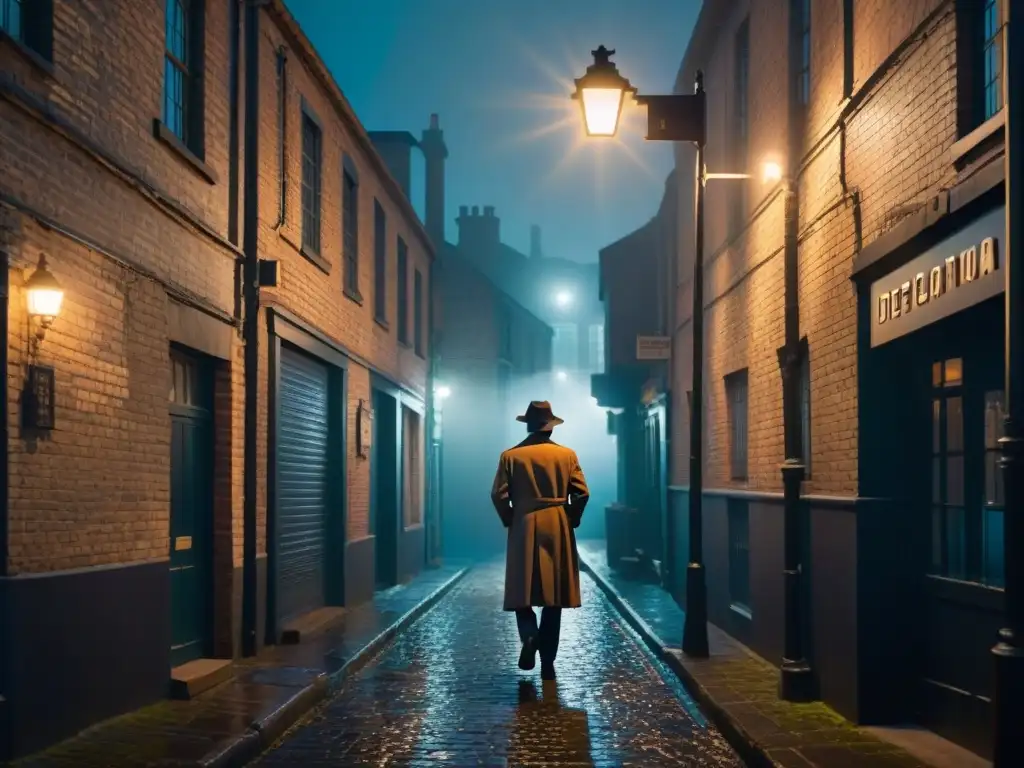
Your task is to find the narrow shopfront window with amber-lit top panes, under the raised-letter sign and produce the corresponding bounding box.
[932,358,967,579]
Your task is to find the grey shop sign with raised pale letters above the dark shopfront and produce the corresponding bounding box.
[870,208,1006,347]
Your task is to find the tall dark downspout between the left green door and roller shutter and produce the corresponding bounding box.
[242,0,262,656]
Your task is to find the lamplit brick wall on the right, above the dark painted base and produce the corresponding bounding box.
[673,0,957,495]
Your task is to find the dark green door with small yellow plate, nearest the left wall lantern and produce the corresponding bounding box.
[170,349,213,668]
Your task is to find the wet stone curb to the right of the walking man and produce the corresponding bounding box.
[580,556,779,768]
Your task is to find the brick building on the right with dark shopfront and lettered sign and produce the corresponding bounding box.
[671,0,1004,754]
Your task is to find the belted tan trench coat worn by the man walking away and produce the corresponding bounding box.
[490,432,590,610]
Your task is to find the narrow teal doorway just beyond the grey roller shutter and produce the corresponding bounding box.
[370,389,401,589]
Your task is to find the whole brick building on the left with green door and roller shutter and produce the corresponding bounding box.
[0,0,432,758]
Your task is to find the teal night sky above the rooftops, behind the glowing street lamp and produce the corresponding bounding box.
[287,0,700,261]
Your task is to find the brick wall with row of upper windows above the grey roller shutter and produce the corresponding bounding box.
[258,6,431,552]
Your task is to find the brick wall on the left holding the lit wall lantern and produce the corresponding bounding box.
[0,0,241,572]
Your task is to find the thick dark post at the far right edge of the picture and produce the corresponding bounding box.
[992,0,1024,768]
